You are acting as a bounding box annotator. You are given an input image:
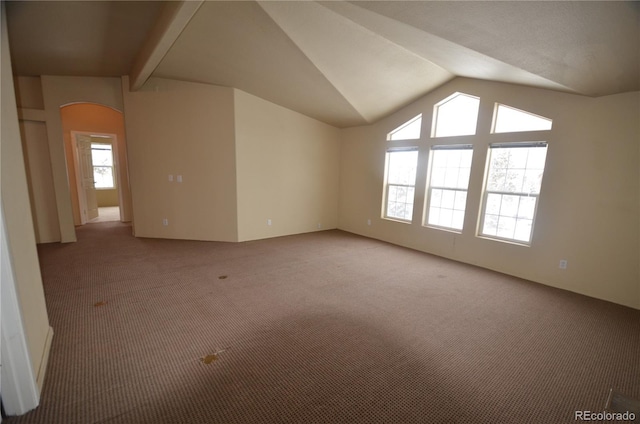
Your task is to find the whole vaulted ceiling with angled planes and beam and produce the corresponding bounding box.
[6,1,640,127]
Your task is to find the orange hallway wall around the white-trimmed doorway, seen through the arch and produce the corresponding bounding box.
[60,103,132,225]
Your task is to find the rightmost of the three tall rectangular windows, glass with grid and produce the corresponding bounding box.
[480,142,547,244]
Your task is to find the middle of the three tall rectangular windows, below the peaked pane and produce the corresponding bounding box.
[425,145,473,231]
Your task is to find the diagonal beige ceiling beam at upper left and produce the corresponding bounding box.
[130,0,204,91]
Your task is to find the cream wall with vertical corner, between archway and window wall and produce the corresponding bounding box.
[124,78,340,241]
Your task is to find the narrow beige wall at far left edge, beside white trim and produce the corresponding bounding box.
[0,5,53,389]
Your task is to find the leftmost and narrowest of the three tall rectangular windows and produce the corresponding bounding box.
[384,148,418,222]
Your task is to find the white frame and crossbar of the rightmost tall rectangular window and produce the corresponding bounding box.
[477,141,548,246]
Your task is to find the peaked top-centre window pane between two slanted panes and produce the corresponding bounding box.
[431,93,480,137]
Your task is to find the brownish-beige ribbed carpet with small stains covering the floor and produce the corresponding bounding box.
[6,223,640,424]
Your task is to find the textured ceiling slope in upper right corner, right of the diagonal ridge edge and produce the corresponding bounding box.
[357,1,640,96]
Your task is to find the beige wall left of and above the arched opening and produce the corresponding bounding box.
[41,75,126,242]
